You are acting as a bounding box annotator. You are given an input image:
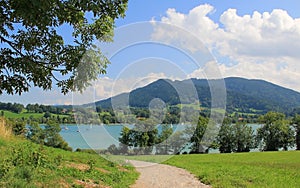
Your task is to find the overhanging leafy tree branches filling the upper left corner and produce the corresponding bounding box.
[0,0,128,94]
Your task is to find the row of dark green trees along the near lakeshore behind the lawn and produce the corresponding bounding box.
[110,112,300,154]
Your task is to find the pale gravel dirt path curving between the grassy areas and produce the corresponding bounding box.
[129,160,210,188]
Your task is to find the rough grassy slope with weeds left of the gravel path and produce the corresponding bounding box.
[0,118,138,188]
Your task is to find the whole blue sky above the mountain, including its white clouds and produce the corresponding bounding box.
[0,0,300,104]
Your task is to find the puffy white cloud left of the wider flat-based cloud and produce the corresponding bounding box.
[151,4,223,52]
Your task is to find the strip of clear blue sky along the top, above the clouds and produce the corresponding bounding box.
[117,0,300,26]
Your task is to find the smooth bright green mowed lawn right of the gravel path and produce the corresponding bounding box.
[164,151,300,188]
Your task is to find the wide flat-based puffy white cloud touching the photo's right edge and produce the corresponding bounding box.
[215,9,300,58]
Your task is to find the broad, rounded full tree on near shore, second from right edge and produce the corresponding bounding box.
[257,112,295,151]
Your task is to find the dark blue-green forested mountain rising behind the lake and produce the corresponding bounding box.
[96,77,300,113]
